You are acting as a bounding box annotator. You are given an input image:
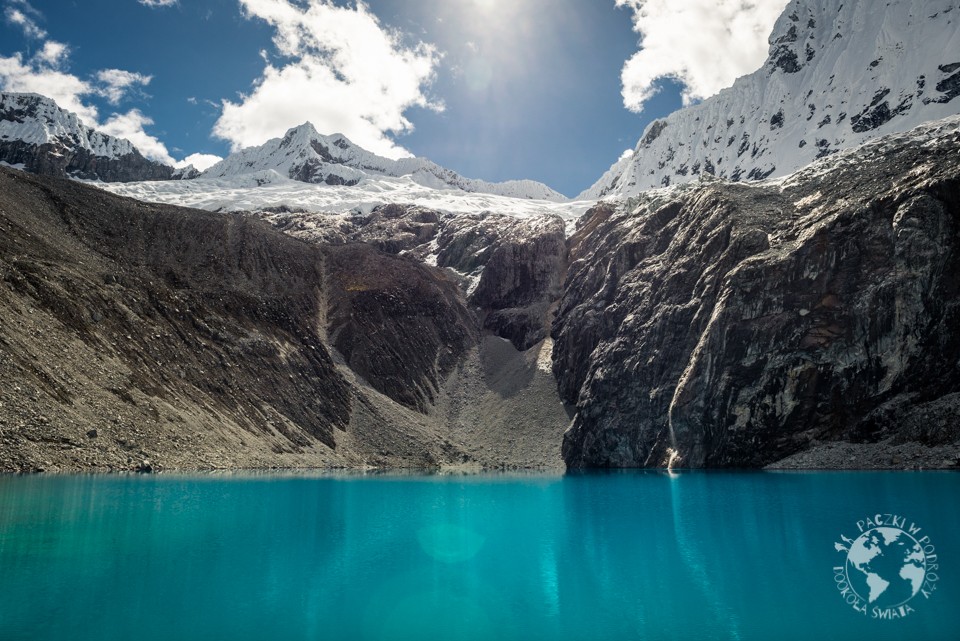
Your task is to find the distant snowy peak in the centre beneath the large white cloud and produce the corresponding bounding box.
[201,122,566,202]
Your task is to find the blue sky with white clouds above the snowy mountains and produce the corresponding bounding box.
[0,0,786,195]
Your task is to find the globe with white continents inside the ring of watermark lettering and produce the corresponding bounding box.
[846,527,926,608]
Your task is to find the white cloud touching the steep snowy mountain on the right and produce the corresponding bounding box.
[616,0,787,112]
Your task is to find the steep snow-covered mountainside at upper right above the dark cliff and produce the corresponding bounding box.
[579,0,960,199]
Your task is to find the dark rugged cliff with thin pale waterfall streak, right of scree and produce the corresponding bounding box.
[553,127,960,468]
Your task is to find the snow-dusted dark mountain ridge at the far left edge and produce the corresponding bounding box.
[0,92,184,182]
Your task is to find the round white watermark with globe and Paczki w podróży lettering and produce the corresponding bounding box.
[833,514,940,619]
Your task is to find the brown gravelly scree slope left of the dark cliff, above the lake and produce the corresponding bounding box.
[0,168,569,471]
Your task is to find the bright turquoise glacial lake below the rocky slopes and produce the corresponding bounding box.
[0,472,960,641]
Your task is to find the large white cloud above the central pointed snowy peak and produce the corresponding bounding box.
[213,0,443,157]
